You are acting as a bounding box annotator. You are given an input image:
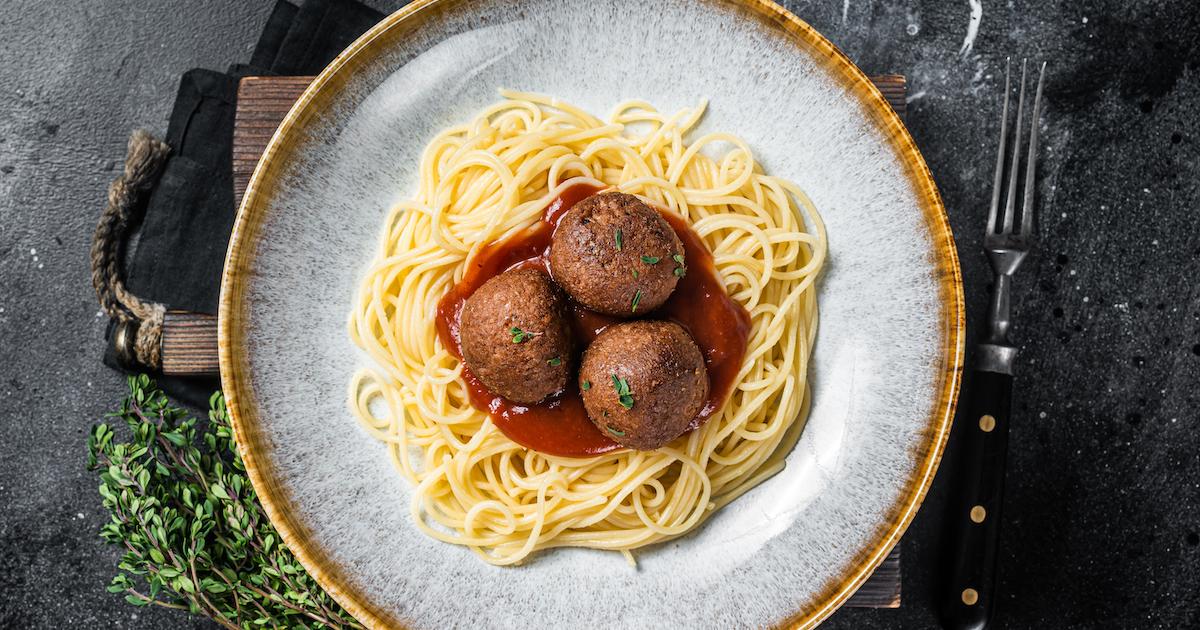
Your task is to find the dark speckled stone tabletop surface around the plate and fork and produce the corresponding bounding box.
[0,0,1200,628]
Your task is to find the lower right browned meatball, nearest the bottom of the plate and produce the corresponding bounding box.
[580,320,708,450]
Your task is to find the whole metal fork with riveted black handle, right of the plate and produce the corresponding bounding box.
[938,60,1046,630]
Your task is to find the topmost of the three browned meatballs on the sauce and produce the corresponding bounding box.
[550,192,683,317]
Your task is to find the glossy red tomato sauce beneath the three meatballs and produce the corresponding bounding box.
[437,184,750,457]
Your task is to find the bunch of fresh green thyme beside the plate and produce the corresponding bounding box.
[88,374,360,628]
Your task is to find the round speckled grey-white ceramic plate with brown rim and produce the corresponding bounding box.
[220,0,962,628]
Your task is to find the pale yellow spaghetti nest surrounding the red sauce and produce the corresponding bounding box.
[349,91,827,564]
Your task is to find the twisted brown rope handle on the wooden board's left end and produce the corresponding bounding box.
[91,130,170,370]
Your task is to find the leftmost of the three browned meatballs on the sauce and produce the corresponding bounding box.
[460,269,572,403]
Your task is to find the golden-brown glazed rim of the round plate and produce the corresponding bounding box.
[218,0,965,628]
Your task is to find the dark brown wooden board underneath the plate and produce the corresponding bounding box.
[174,74,907,608]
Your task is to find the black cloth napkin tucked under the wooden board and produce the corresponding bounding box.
[104,0,384,408]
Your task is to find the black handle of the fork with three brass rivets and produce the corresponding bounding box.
[938,371,1013,630]
